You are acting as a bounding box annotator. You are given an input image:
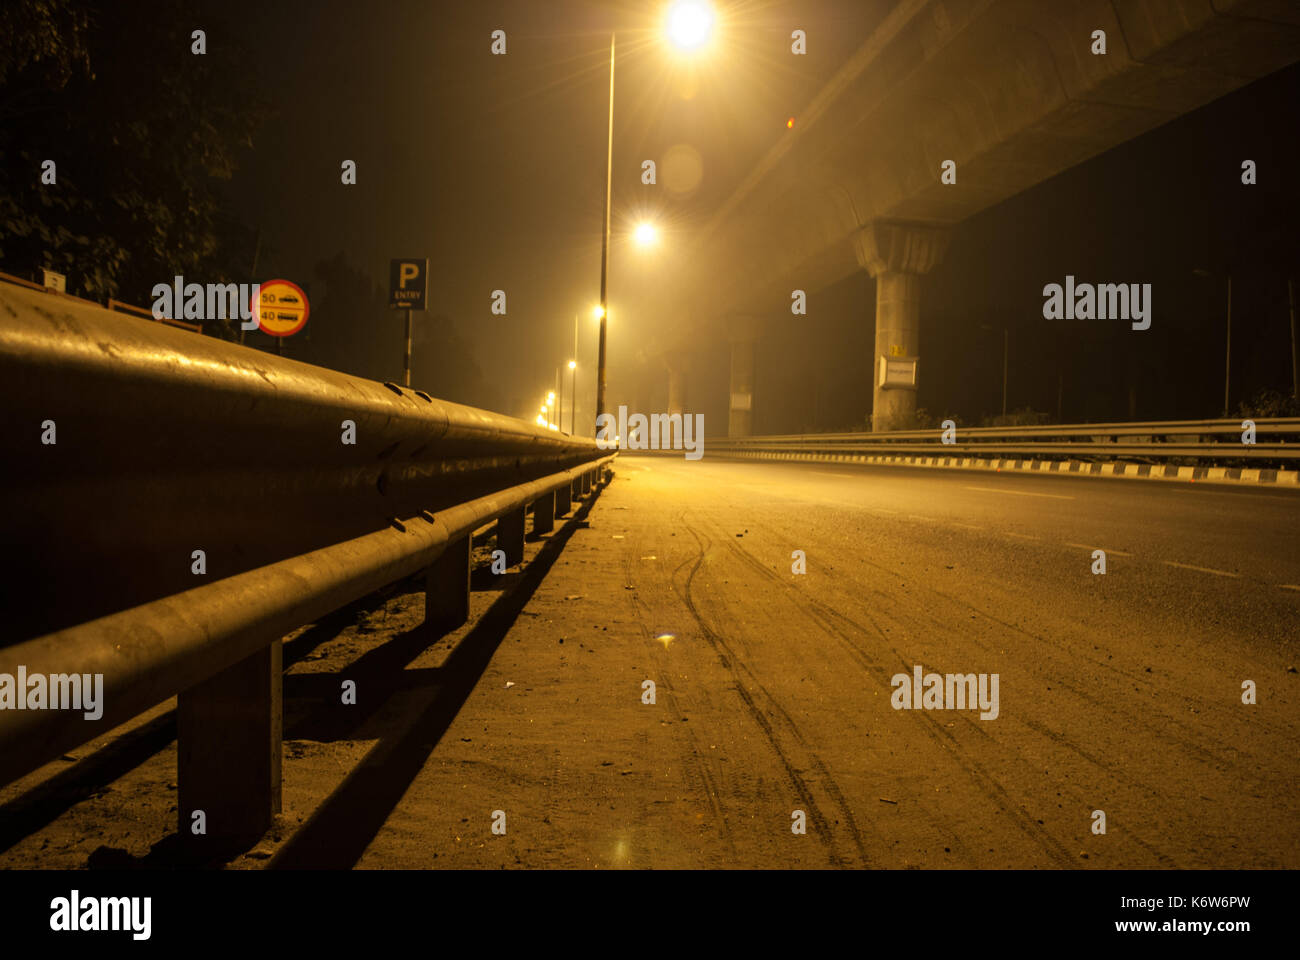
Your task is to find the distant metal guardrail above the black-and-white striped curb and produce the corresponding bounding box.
[706,418,1300,463]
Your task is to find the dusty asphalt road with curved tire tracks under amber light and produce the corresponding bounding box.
[0,455,1300,869]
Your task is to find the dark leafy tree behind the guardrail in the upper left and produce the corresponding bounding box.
[0,0,267,337]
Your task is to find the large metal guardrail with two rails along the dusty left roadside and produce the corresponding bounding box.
[0,278,614,840]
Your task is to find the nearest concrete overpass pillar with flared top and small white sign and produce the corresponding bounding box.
[854,220,950,431]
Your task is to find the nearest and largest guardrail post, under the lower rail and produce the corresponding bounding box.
[176,640,283,856]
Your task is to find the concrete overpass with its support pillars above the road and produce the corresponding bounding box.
[655,0,1300,436]
